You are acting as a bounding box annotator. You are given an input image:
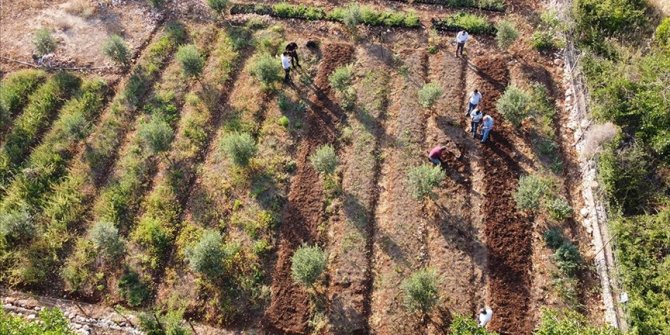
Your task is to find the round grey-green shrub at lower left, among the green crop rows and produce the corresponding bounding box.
[186,230,230,279]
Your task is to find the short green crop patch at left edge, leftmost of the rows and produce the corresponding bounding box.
[0,70,47,126]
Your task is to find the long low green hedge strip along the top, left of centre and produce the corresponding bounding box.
[230,3,421,28]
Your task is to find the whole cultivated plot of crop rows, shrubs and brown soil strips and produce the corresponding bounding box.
[0,0,624,334]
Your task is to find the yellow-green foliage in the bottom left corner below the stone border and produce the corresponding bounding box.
[0,308,76,335]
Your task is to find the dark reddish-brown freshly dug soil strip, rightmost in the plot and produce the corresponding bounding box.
[468,55,532,334]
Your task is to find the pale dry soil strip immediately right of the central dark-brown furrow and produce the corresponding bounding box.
[328,44,391,334]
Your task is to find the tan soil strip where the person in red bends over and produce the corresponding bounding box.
[425,52,486,330]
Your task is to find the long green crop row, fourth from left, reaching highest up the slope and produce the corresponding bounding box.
[1,24,189,283]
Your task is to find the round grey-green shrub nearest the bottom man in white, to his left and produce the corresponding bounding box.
[400,269,440,314]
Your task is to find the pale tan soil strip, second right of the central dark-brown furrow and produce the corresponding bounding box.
[369,49,427,334]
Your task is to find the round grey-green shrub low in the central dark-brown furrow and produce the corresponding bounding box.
[291,245,327,287]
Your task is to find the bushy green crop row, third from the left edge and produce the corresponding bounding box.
[0,80,109,210]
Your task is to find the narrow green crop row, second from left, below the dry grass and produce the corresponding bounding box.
[0,72,81,188]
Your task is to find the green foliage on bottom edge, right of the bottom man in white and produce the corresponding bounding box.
[533,308,621,335]
